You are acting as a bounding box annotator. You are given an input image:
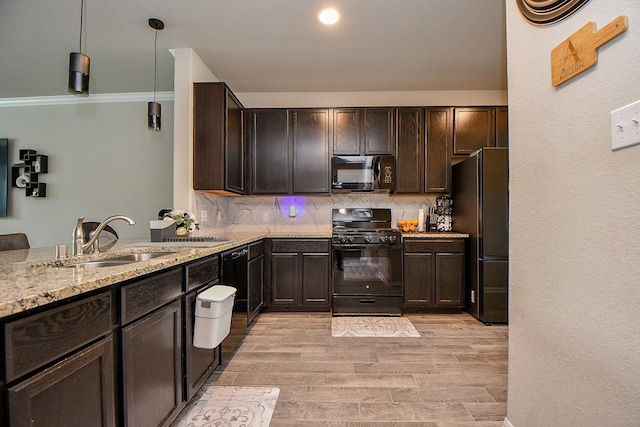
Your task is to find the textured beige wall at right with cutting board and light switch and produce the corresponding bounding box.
[505,0,640,427]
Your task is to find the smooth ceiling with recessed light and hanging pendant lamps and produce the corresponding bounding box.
[0,0,507,98]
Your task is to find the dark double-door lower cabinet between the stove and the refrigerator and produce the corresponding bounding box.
[404,239,465,308]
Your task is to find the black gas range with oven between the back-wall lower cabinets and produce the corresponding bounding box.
[331,208,403,316]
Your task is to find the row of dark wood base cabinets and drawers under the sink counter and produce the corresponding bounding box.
[0,254,226,427]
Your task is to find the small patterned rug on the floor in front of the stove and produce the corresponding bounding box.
[331,316,420,337]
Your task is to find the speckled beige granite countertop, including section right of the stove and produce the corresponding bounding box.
[0,229,468,318]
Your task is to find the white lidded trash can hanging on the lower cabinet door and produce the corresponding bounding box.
[193,285,236,348]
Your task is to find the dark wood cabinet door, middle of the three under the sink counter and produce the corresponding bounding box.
[122,300,184,427]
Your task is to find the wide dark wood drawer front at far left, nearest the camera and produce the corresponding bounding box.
[4,292,113,382]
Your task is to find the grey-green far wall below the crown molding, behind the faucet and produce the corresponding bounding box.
[0,93,173,247]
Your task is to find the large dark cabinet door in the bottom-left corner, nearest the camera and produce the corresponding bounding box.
[8,337,116,427]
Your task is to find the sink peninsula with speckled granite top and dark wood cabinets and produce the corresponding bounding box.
[0,232,328,427]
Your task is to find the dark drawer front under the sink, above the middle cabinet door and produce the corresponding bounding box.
[121,268,182,324]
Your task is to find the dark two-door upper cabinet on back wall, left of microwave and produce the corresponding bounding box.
[250,109,331,194]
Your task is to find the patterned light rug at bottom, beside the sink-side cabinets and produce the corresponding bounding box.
[173,386,280,427]
